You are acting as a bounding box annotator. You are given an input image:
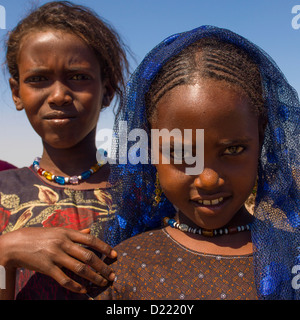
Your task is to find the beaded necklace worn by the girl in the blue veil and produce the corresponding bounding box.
[163,217,251,237]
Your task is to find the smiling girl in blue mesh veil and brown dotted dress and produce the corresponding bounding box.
[97,26,300,299]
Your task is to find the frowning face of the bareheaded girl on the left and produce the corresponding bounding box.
[10,30,110,148]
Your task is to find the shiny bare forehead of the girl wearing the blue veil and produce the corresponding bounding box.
[155,80,258,134]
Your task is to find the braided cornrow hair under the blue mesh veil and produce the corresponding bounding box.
[145,38,266,126]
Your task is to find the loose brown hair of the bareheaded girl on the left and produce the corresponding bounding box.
[6,1,129,109]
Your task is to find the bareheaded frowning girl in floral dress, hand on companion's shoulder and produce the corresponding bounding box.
[0,1,127,299]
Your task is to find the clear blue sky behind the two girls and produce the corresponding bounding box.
[0,0,300,166]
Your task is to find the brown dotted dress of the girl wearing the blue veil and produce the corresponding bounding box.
[96,229,257,300]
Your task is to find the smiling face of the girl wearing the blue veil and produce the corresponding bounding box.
[152,80,259,229]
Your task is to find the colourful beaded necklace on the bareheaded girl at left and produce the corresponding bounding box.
[33,157,104,185]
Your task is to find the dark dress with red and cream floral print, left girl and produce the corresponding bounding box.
[0,168,114,299]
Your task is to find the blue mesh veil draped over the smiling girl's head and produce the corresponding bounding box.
[106,26,300,299]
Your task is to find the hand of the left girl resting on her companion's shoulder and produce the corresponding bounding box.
[0,228,117,293]
